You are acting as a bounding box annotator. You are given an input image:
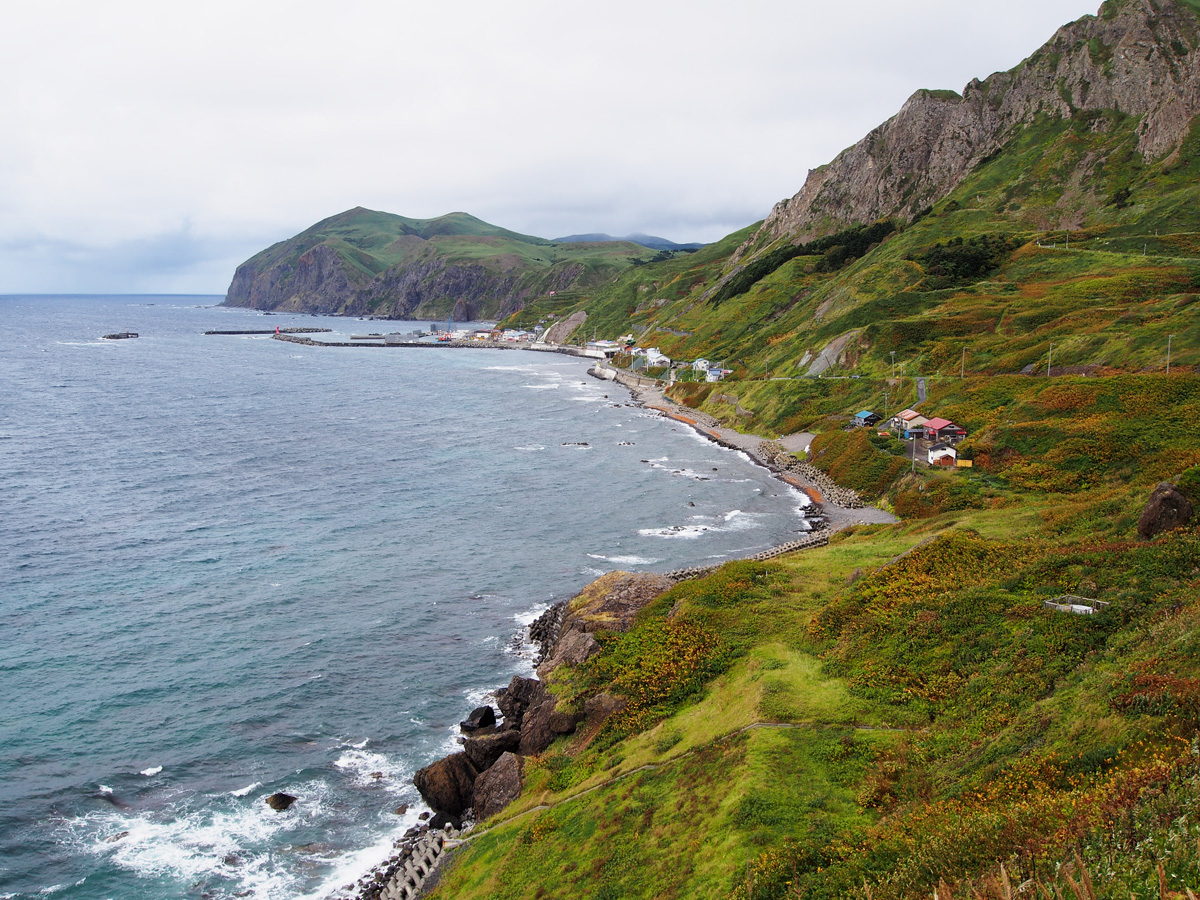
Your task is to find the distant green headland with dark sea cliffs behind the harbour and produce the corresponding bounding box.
[224,206,655,320]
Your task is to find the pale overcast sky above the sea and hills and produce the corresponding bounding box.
[0,0,1099,294]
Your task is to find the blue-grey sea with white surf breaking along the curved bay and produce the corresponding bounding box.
[0,296,805,900]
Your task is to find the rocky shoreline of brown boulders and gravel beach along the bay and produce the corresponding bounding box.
[336,362,895,900]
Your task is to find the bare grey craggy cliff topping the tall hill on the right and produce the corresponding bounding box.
[760,0,1200,241]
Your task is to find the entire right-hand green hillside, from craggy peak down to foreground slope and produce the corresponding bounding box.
[432,0,1200,900]
